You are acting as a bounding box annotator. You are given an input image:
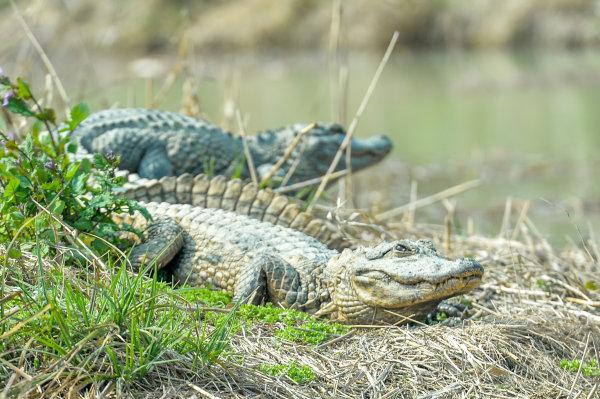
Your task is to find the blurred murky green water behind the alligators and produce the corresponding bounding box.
[87,51,600,242]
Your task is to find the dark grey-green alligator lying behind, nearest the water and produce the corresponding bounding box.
[73,108,392,184]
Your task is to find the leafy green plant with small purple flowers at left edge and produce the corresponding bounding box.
[0,76,149,258]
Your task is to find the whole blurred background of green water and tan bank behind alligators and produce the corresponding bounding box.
[0,0,600,243]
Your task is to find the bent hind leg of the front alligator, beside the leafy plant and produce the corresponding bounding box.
[129,216,184,271]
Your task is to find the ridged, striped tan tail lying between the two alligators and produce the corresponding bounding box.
[117,173,352,250]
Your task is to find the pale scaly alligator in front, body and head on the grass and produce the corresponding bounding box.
[122,202,483,324]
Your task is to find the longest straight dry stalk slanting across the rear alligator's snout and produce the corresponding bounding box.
[308,31,399,210]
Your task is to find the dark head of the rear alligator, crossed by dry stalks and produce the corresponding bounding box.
[249,123,392,184]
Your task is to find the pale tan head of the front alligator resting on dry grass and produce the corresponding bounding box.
[322,240,483,324]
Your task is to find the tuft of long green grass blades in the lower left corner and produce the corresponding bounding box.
[0,256,237,396]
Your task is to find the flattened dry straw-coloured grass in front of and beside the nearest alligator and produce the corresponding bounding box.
[17,212,600,398]
